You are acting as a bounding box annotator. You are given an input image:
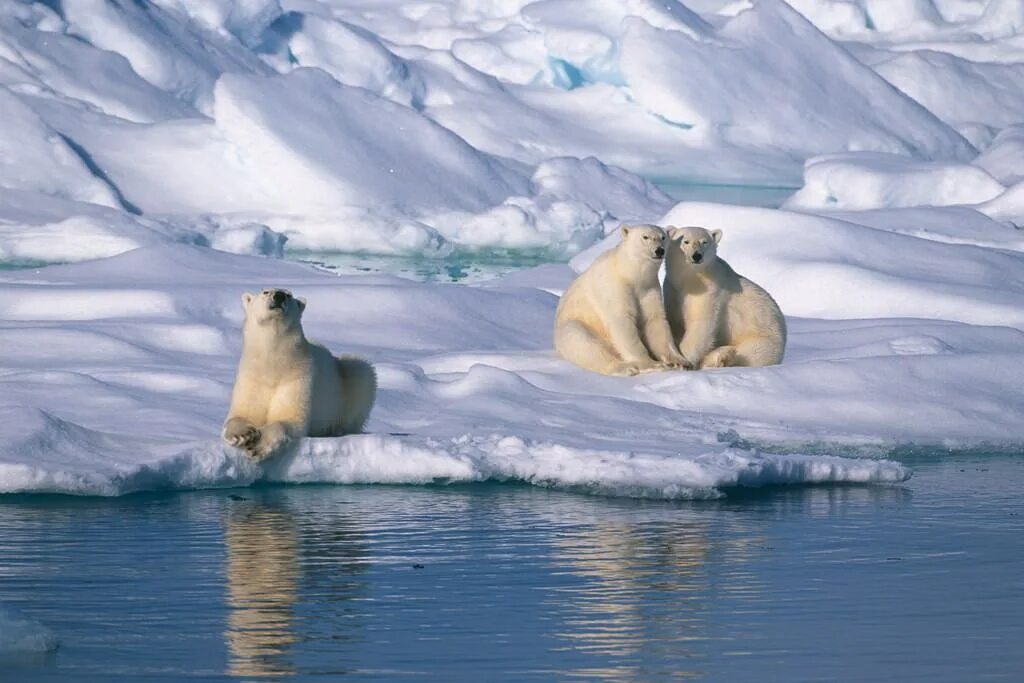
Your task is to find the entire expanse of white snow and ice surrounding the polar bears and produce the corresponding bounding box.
[0,0,1024,501]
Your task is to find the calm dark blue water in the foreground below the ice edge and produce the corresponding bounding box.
[0,456,1024,683]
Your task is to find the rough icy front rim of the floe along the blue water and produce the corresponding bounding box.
[0,428,910,501]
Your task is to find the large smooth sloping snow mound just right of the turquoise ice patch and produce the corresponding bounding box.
[622,0,973,166]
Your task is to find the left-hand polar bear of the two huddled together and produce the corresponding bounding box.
[555,225,685,376]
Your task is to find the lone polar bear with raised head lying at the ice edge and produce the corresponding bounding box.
[223,289,377,460]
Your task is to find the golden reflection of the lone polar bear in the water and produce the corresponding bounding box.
[224,505,300,676]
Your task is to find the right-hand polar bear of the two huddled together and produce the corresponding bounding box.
[665,227,785,368]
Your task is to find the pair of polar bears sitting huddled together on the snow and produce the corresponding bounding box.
[555,225,785,375]
